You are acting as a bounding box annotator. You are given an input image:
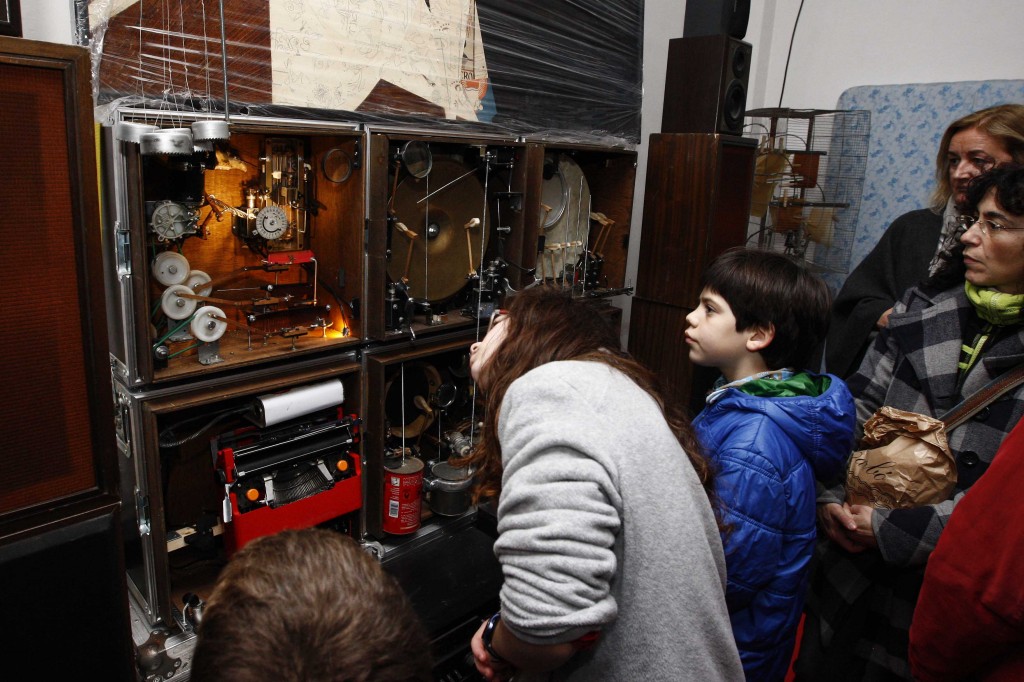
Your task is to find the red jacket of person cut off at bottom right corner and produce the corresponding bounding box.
[910,421,1024,682]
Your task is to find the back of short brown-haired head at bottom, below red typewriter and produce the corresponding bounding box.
[191,528,433,682]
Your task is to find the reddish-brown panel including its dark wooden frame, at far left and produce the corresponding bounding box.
[0,38,117,520]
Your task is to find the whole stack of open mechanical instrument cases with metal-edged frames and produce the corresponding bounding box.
[102,110,636,682]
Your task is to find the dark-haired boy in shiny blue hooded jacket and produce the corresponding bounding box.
[685,249,856,680]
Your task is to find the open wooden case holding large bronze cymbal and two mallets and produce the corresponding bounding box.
[366,128,528,341]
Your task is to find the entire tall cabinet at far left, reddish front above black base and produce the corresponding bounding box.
[0,38,131,680]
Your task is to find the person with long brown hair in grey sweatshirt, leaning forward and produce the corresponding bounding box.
[467,287,743,681]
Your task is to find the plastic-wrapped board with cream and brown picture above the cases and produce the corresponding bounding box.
[79,0,643,146]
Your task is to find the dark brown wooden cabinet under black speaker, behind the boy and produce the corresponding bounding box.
[629,133,757,409]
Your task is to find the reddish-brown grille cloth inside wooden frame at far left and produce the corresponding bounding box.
[0,63,103,513]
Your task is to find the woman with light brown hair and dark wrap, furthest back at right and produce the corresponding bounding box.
[825,104,1024,378]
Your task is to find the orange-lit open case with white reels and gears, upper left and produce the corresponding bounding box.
[102,110,367,387]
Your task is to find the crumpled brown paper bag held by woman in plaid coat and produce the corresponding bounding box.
[846,407,956,509]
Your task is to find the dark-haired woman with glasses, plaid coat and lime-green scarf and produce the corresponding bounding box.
[796,164,1024,680]
